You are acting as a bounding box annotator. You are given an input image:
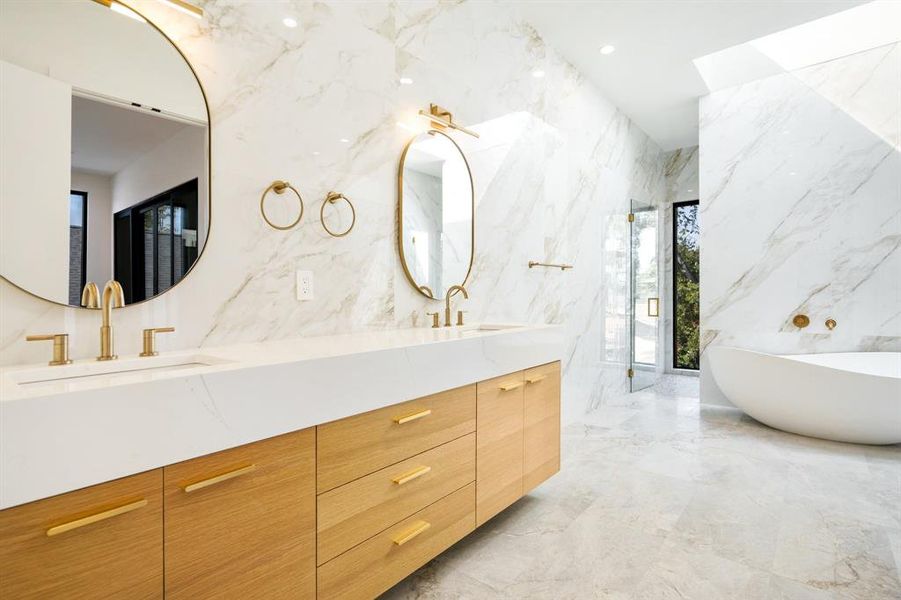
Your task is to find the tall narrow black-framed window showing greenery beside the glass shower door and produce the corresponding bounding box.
[673,200,701,369]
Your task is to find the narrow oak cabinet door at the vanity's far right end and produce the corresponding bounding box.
[522,361,560,494]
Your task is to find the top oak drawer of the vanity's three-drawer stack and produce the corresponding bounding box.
[316,384,476,493]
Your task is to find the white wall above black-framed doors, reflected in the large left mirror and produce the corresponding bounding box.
[112,127,210,239]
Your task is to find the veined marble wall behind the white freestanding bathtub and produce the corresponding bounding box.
[700,44,901,404]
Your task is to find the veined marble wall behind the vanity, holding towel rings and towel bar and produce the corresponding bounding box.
[0,0,664,419]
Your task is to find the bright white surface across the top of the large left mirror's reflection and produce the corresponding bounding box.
[0,0,207,123]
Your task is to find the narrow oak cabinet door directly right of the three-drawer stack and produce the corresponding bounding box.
[476,371,525,526]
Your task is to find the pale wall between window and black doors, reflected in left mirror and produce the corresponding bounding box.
[72,171,113,288]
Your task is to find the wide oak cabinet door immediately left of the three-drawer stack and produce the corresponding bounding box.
[163,428,316,600]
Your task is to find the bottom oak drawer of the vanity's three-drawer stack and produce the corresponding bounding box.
[317,483,475,600]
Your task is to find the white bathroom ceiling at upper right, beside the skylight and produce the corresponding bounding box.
[522,0,865,150]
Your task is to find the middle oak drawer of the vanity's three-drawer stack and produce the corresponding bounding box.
[317,433,476,564]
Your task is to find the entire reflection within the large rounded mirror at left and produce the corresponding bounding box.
[0,0,209,306]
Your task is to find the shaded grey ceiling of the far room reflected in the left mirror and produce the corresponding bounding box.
[72,96,195,175]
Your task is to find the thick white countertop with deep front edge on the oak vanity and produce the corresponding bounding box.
[0,325,563,509]
